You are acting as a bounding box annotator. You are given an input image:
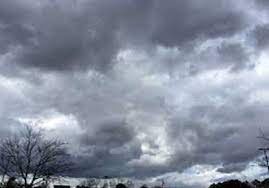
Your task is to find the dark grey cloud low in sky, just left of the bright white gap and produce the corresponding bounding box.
[71,120,142,177]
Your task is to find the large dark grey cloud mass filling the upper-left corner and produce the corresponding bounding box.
[1,1,118,70]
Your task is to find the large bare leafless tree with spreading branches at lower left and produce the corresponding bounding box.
[0,126,72,188]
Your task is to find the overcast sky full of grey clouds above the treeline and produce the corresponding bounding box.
[0,0,269,187]
